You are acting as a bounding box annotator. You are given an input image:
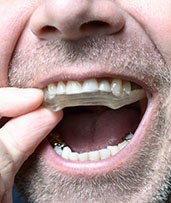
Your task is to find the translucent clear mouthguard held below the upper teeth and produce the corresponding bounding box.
[43,89,146,111]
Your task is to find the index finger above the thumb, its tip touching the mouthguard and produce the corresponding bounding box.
[0,87,43,118]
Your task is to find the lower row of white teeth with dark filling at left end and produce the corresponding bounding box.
[54,133,133,161]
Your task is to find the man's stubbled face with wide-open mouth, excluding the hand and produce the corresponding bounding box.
[0,0,171,203]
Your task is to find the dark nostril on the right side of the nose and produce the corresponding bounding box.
[80,20,110,32]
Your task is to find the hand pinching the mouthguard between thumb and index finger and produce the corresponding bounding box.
[0,88,62,203]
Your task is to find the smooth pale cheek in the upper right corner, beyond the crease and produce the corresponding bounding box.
[118,0,171,66]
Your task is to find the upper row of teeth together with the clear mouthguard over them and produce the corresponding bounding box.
[44,79,145,111]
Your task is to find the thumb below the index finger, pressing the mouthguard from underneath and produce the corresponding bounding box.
[0,108,62,170]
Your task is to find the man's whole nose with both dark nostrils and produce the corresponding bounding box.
[30,0,125,40]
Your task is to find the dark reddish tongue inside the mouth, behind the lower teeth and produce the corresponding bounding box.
[57,107,140,152]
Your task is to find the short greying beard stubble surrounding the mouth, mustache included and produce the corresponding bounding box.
[9,34,171,203]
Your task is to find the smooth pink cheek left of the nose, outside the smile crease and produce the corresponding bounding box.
[0,0,38,86]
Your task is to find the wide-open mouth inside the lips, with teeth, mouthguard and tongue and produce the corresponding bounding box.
[44,78,147,167]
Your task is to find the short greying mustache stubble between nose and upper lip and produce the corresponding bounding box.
[9,36,171,91]
